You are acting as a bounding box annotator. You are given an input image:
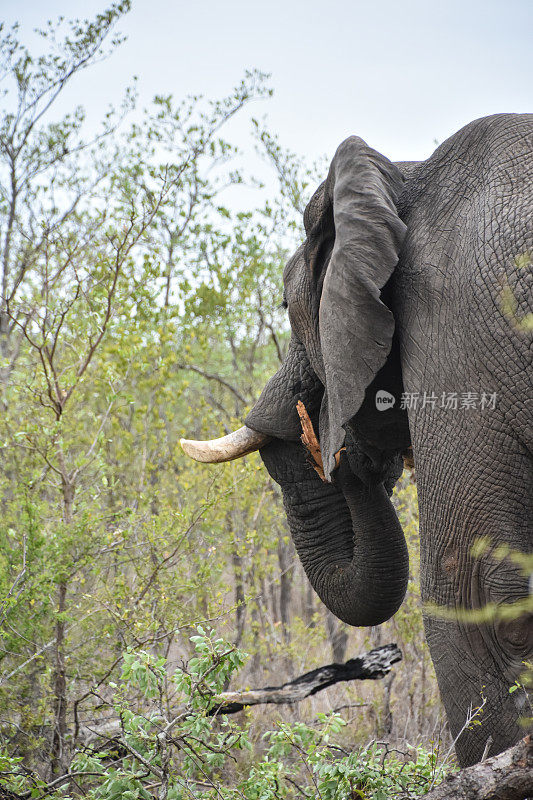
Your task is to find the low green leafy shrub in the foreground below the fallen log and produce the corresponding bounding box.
[0,626,450,800]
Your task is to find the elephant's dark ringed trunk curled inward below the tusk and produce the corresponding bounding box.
[261,443,409,626]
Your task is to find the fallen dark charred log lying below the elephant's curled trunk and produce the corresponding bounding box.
[209,644,402,716]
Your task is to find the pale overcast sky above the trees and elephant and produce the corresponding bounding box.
[0,0,533,167]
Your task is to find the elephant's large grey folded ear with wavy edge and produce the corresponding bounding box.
[310,136,406,477]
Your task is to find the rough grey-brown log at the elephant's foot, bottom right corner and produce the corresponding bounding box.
[424,736,533,800]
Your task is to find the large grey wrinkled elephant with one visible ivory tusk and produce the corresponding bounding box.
[182,114,533,766]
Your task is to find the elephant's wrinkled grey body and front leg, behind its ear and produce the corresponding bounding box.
[392,115,533,764]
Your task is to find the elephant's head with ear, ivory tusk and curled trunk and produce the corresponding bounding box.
[182,136,410,625]
